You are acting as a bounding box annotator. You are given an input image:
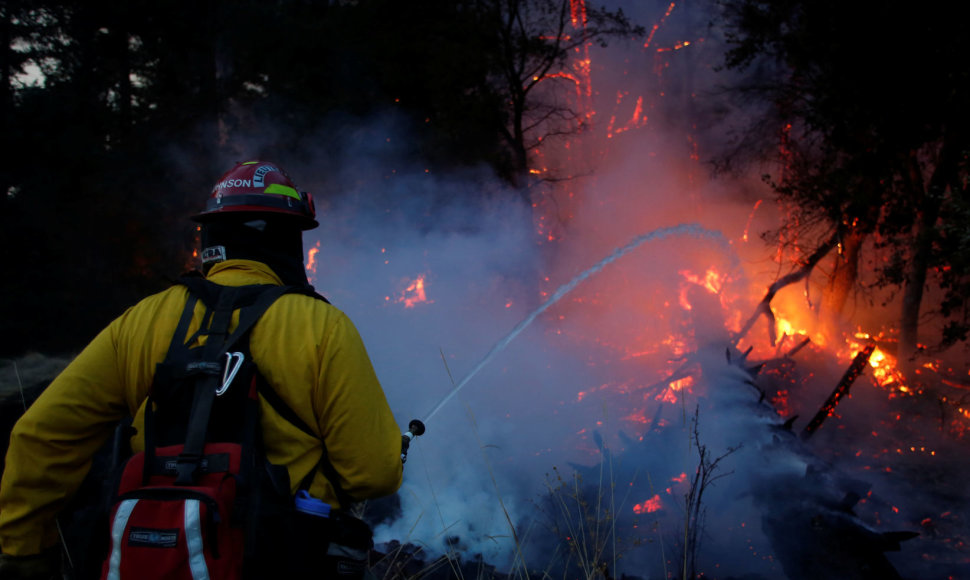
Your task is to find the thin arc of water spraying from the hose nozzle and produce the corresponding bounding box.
[421,224,727,422]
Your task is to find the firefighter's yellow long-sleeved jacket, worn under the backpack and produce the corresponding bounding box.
[0,260,401,555]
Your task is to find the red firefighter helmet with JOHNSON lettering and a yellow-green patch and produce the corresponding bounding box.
[192,161,320,230]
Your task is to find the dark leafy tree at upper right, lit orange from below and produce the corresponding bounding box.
[722,0,970,376]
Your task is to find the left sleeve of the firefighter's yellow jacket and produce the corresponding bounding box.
[0,316,128,555]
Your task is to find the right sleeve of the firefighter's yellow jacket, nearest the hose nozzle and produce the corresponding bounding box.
[313,313,402,500]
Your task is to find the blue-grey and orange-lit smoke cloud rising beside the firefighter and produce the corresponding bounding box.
[5,3,963,578]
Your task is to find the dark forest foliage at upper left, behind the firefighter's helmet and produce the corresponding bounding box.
[0,0,631,355]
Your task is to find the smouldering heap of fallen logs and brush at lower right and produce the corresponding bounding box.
[528,270,970,580]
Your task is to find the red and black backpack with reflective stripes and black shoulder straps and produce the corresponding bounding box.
[101,278,373,580]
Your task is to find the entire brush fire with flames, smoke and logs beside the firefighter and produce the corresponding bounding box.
[3,0,970,580]
